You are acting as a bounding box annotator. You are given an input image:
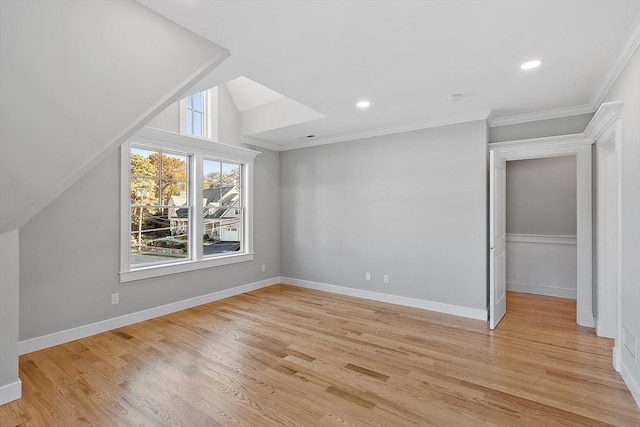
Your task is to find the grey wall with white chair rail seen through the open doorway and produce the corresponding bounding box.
[506,156,577,301]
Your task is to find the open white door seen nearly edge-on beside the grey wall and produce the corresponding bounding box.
[489,151,507,329]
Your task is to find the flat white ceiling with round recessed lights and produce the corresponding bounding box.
[139,0,640,148]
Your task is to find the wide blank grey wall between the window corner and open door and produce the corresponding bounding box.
[280,121,487,311]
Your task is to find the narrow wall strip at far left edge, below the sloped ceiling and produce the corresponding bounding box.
[0,230,21,405]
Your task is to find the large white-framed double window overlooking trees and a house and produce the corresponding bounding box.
[121,128,259,282]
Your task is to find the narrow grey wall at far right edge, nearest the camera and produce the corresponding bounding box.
[605,49,640,405]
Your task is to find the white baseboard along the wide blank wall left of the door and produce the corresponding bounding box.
[280,277,487,322]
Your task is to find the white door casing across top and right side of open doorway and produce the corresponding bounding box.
[489,134,595,328]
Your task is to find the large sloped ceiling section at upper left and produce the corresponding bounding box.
[0,0,229,234]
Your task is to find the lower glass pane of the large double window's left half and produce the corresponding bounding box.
[131,208,189,266]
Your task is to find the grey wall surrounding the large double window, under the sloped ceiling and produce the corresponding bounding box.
[18,145,280,342]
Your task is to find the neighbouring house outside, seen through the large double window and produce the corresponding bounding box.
[169,186,241,242]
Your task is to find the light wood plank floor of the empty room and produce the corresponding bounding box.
[0,285,640,427]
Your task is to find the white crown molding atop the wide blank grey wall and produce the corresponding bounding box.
[281,110,491,151]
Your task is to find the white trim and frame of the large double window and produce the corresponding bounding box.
[120,127,260,283]
